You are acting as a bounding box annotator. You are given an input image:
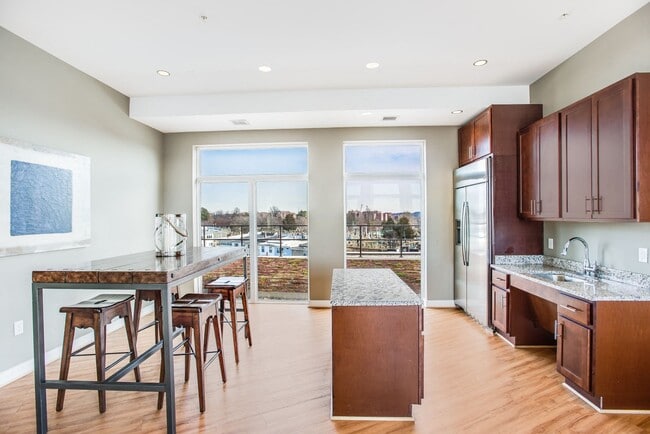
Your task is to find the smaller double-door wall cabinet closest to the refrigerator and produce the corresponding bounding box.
[518,113,560,220]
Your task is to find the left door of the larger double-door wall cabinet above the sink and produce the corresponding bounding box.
[562,98,594,219]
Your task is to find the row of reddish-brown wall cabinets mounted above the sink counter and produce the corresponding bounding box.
[519,73,650,221]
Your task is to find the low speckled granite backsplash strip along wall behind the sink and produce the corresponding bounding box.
[494,255,650,288]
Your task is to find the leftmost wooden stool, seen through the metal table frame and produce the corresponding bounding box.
[56,294,140,413]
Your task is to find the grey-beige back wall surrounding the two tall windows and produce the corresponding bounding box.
[164,127,457,300]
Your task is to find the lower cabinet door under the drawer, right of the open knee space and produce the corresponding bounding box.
[557,316,591,392]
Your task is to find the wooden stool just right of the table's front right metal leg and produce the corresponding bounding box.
[158,293,226,412]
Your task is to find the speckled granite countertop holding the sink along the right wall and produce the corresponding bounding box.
[492,261,650,301]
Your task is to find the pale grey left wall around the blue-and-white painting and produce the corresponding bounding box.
[0,28,162,376]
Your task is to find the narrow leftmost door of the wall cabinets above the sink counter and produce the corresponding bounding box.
[519,127,539,218]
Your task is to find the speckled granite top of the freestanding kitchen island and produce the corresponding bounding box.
[331,268,422,306]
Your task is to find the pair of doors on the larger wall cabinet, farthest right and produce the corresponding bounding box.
[561,78,635,220]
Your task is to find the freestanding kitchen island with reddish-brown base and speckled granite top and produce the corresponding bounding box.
[331,269,424,420]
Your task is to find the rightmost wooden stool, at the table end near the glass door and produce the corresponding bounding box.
[203,276,253,363]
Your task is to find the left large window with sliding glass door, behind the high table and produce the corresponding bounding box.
[196,144,309,301]
